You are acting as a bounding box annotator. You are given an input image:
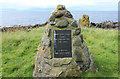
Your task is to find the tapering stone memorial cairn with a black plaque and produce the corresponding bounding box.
[33,5,97,77]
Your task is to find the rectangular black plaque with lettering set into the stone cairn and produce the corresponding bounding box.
[54,30,72,58]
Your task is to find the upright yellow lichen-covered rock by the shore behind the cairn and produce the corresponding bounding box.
[79,15,91,27]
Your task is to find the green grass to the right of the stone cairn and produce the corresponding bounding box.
[82,28,118,77]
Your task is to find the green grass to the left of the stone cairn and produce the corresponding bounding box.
[2,28,44,77]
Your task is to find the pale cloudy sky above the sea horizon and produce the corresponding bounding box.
[0,0,119,11]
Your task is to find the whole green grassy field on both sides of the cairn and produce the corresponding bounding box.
[2,27,118,77]
